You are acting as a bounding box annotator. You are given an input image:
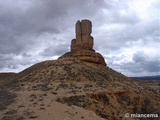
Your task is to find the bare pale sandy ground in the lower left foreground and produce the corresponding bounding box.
[0,91,104,120]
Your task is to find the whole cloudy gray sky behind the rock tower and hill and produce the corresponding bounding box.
[0,0,160,76]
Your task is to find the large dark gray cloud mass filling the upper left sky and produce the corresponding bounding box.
[0,0,106,53]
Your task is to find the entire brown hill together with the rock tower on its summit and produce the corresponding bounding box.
[0,20,160,120]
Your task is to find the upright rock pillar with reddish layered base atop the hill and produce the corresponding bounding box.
[59,20,106,66]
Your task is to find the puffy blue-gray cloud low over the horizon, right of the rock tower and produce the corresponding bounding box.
[109,51,160,76]
